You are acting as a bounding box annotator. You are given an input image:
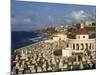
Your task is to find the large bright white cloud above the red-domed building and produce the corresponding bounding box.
[65,10,95,23]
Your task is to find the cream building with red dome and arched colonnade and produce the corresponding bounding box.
[68,24,95,53]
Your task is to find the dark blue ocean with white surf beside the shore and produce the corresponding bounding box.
[11,31,48,52]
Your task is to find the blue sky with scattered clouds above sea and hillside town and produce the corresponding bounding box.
[11,0,96,31]
